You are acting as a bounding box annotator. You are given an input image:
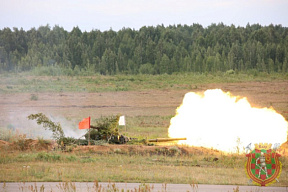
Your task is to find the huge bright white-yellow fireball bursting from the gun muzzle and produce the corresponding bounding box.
[168,89,288,152]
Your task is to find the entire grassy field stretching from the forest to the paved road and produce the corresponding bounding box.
[0,73,288,186]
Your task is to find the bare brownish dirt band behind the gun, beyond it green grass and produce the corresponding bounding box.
[0,81,288,127]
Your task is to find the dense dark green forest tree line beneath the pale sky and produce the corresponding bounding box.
[0,23,288,75]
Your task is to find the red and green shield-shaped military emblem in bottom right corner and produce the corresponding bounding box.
[245,143,282,186]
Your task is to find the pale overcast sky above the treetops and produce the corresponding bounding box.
[0,0,288,32]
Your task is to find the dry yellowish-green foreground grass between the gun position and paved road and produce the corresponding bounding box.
[0,146,288,186]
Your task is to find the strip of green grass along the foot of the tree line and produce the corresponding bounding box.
[0,73,288,93]
